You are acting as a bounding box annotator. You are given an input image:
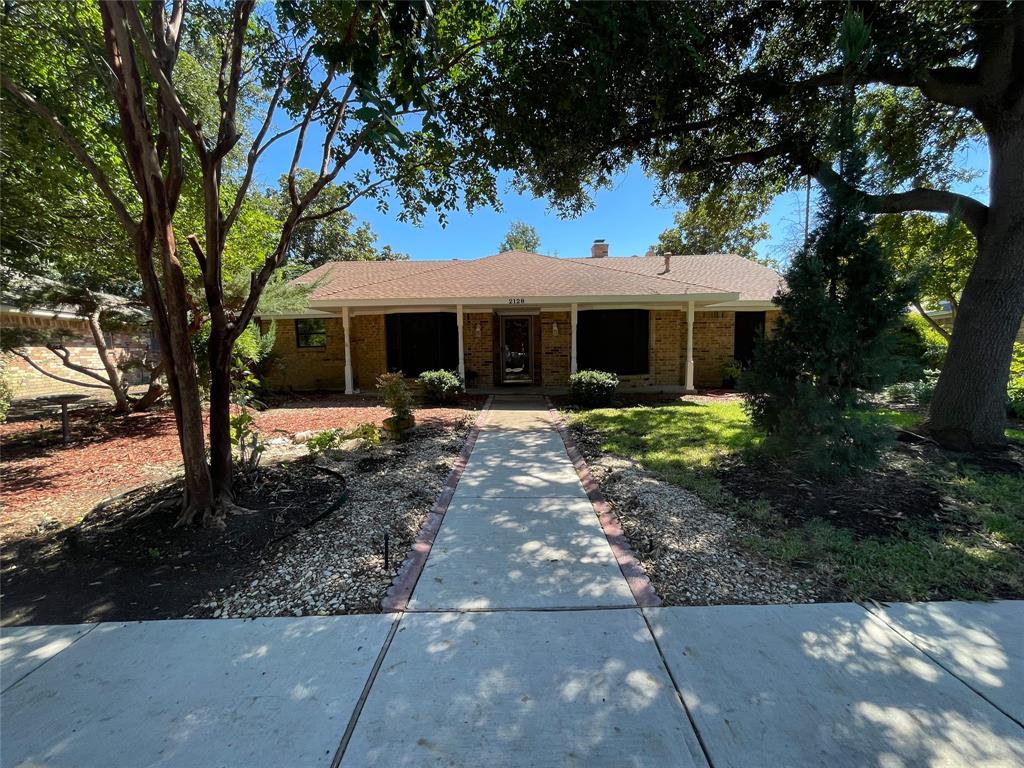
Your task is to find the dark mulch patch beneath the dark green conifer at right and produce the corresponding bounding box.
[718,445,962,537]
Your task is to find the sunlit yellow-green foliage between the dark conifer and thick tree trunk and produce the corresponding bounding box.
[873,213,976,341]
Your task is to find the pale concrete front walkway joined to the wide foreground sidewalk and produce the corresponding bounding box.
[0,401,1024,768]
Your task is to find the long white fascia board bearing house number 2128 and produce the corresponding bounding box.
[309,293,739,311]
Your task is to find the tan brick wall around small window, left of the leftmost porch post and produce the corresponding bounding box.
[260,317,345,389]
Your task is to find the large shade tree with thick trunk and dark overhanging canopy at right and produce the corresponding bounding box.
[450,0,1024,446]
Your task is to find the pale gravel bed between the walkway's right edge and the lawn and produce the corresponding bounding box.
[570,426,824,605]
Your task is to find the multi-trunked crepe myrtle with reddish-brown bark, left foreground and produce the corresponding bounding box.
[3,0,495,525]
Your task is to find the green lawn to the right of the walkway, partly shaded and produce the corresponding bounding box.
[570,400,1024,600]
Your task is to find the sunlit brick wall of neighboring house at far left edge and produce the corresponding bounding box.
[2,312,148,399]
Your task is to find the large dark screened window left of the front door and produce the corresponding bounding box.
[387,312,459,376]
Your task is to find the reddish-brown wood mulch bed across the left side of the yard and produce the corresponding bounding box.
[0,394,485,545]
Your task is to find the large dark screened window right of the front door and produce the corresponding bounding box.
[577,309,650,376]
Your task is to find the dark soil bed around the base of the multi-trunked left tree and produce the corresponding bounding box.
[0,459,344,626]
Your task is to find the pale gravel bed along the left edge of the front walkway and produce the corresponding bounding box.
[193,416,472,618]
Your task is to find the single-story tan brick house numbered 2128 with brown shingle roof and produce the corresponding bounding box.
[261,241,781,392]
